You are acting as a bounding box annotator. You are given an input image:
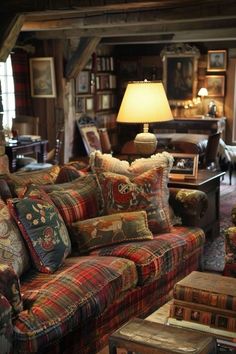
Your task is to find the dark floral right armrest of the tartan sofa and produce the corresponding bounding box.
[169,188,208,226]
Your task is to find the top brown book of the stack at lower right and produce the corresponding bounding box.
[173,271,236,311]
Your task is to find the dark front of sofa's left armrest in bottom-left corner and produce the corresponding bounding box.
[0,294,13,354]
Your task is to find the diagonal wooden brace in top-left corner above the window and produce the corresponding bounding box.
[0,15,25,61]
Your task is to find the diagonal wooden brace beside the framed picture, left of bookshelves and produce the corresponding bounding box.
[65,37,100,79]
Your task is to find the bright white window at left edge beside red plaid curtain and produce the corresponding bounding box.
[0,55,15,129]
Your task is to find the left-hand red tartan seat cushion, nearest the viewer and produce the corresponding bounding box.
[13,256,137,353]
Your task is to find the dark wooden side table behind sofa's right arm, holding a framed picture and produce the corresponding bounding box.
[168,170,225,237]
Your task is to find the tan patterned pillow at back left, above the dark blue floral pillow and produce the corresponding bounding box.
[7,166,60,197]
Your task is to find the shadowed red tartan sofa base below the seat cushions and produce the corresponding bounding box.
[43,248,202,354]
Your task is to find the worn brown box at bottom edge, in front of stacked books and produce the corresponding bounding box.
[109,318,216,354]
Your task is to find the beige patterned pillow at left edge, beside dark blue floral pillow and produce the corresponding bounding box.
[0,200,30,277]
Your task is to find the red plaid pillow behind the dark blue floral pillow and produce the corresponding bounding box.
[26,174,103,226]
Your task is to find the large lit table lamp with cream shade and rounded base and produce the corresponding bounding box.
[117,80,173,155]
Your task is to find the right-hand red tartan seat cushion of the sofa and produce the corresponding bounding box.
[90,227,205,285]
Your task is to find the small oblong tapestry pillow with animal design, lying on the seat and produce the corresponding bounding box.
[72,211,153,253]
